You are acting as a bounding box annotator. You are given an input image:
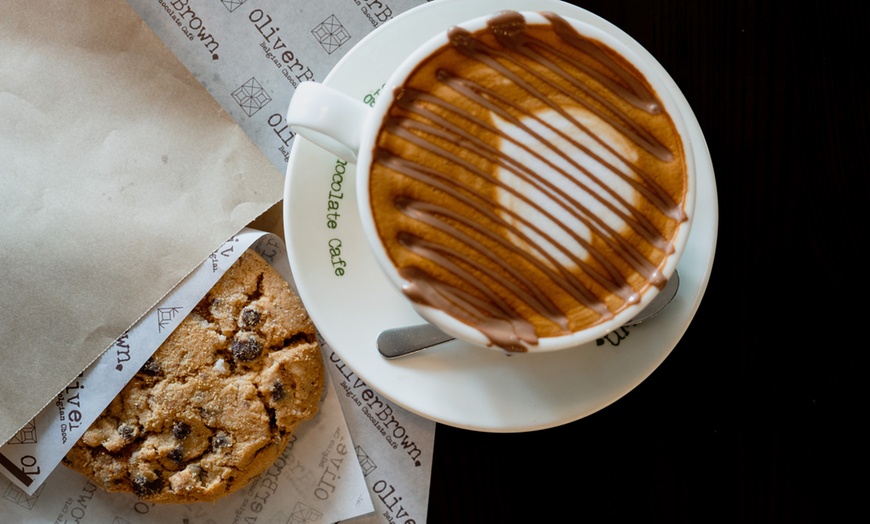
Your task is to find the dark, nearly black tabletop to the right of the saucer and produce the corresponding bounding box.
[429,0,870,524]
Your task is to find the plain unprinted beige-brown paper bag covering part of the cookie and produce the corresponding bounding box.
[0,0,283,442]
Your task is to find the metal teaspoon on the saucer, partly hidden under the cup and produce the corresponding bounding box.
[377,271,680,359]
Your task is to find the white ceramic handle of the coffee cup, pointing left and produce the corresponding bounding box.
[287,81,371,164]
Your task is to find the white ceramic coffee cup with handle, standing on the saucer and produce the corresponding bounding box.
[287,12,695,352]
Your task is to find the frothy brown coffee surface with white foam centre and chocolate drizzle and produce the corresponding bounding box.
[369,11,688,351]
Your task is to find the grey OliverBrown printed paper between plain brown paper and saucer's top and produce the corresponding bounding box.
[127,0,425,172]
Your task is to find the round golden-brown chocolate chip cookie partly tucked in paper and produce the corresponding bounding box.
[64,250,324,503]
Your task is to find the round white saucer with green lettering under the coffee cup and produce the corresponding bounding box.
[284,0,718,432]
